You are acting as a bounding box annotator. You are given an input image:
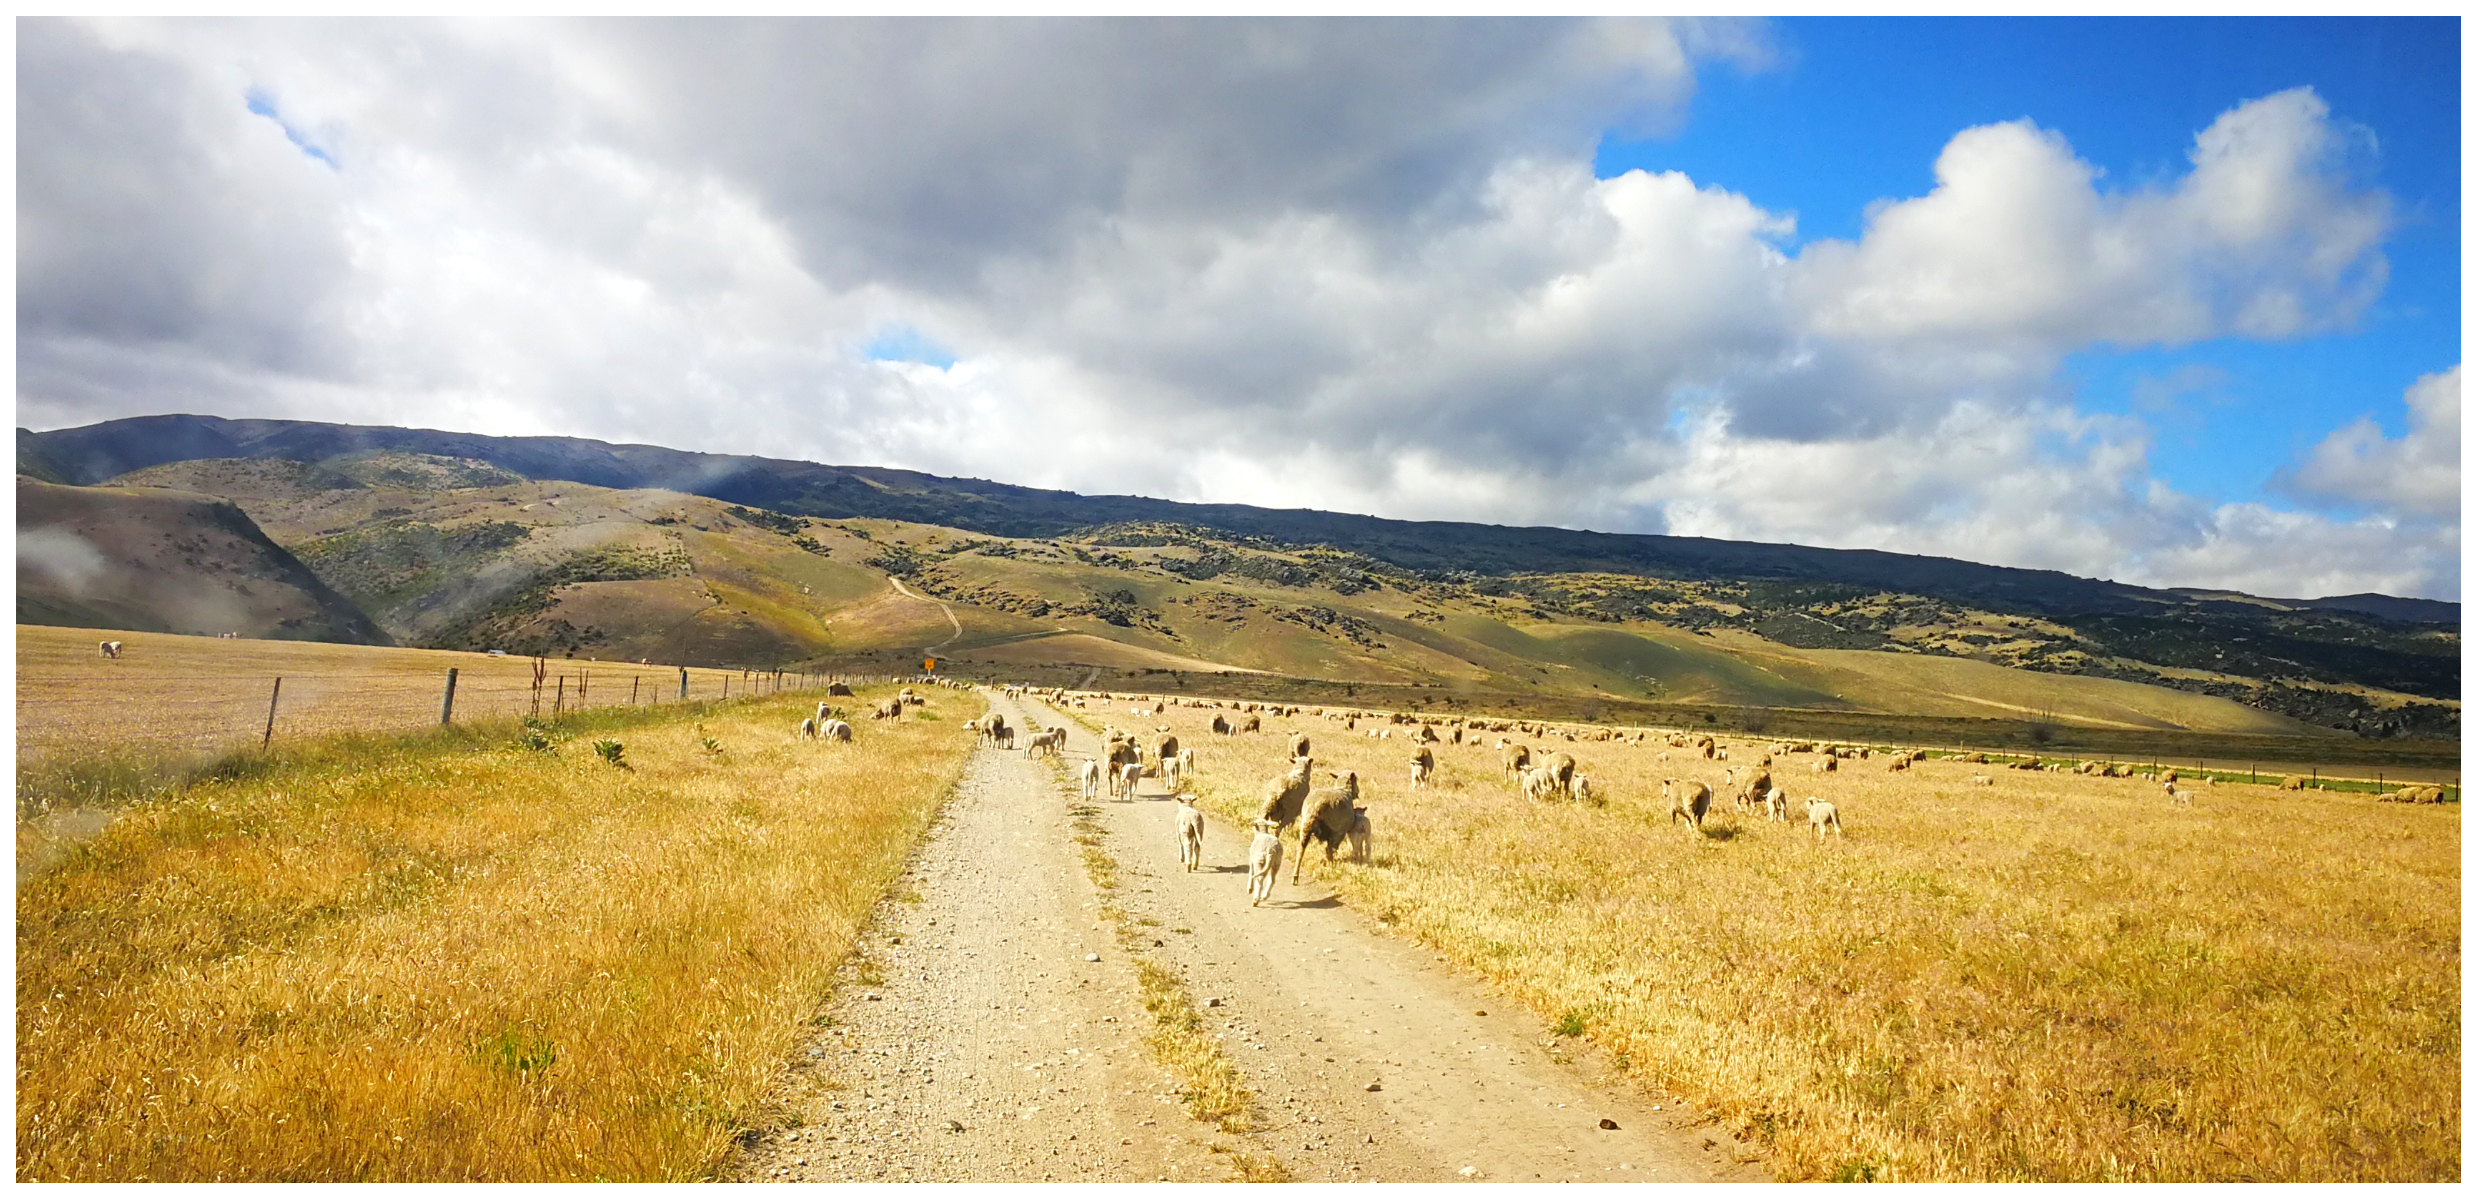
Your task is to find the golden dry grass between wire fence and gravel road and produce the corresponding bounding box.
[17,689,981,1182]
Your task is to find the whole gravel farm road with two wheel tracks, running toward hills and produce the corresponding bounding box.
[736,699,1764,1182]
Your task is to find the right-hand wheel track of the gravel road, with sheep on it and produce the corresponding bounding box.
[1015,706,1766,1182]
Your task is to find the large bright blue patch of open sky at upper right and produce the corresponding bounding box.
[1593,17,2460,505]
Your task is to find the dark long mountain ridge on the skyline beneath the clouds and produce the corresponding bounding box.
[17,416,2460,627]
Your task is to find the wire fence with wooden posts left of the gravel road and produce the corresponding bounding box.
[17,659,911,761]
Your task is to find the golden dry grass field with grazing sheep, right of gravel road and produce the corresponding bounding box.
[1119,701,2460,1182]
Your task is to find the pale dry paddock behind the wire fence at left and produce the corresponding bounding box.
[17,624,837,761]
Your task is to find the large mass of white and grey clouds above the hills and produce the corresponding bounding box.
[17,20,2457,592]
